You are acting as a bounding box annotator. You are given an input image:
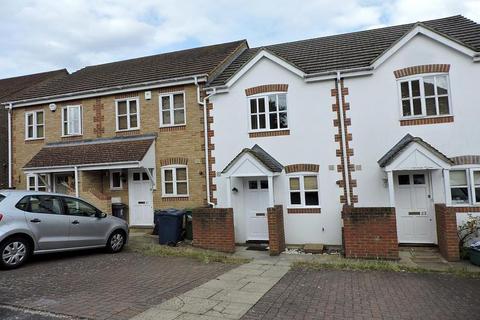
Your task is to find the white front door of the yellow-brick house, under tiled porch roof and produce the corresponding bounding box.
[128,170,153,226]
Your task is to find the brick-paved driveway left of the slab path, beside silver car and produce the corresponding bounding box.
[0,251,233,319]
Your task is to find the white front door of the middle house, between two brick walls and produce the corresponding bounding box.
[244,177,269,240]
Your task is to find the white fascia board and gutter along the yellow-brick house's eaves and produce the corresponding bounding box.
[2,75,207,108]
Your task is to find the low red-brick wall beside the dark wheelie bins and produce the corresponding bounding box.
[192,208,235,253]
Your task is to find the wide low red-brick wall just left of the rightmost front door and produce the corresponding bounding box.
[342,206,399,260]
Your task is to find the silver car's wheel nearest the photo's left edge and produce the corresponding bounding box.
[0,237,30,269]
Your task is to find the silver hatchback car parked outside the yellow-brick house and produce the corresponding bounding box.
[0,190,128,269]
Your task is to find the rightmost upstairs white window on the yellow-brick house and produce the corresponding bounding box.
[159,92,186,127]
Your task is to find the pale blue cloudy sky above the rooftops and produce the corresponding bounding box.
[0,0,480,78]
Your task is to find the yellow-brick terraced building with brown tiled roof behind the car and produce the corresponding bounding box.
[0,41,246,226]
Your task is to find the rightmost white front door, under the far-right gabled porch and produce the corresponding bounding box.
[395,171,437,243]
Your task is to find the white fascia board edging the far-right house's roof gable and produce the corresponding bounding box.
[372,25,477,69]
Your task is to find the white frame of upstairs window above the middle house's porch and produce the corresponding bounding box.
[247,91,290,133]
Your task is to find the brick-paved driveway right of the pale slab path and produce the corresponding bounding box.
[242,270,480,320]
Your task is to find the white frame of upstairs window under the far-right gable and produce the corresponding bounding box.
[397,72,453,120]
